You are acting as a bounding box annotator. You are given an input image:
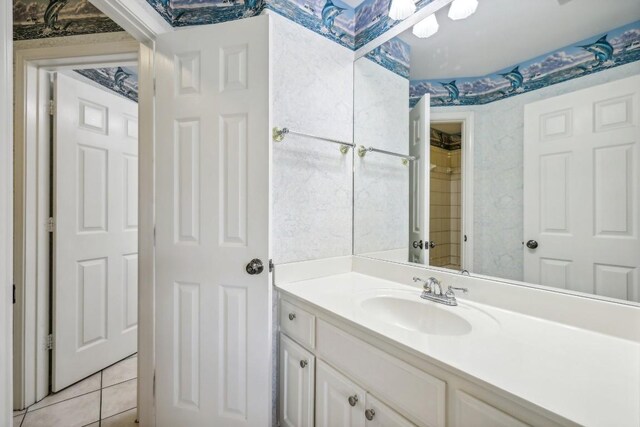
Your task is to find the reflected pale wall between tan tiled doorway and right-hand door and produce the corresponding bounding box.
[432,62,640,280]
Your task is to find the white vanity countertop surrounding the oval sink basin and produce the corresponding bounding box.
[277,272,640,427]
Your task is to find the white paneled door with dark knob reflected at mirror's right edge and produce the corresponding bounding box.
[524,76,640,302]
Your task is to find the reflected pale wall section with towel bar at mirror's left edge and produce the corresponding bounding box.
[354,58,409,260]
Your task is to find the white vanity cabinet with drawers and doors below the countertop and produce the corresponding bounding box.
[279,298,575,427]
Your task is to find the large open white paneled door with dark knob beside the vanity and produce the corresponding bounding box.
[156,16,272,427]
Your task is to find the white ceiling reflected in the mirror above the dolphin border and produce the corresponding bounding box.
[400,0,640,80]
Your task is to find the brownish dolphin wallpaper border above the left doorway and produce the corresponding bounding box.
[13,0,123,40]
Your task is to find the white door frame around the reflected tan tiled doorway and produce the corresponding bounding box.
[431,110,474,271]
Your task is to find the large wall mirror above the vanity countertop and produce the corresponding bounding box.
[353,0,640,303]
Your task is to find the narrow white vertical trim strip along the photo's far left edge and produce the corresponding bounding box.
[0,0,13,426]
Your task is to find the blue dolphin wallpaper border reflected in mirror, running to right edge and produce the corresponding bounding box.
[410,21,640,107]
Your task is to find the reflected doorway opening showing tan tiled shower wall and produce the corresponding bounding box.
[429,122,464,270]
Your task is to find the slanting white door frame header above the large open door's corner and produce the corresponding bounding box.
[91,0,173,43]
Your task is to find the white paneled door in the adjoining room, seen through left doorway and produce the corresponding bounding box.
[52,74,138,391]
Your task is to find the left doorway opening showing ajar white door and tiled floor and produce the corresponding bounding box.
[14,59,138,427]
